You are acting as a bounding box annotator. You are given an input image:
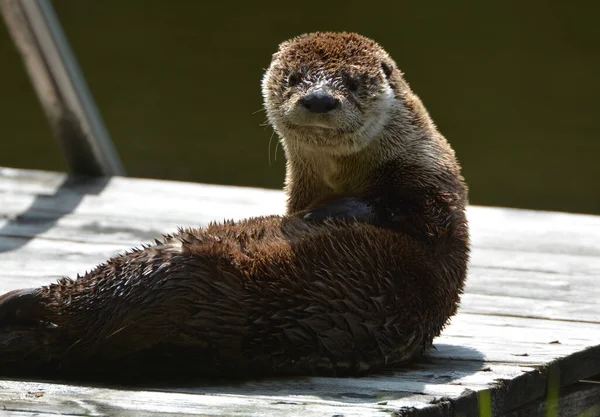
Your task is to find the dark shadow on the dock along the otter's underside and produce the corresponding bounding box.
[0,345,492,404]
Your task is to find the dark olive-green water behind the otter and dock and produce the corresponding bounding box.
[0,0,600,213]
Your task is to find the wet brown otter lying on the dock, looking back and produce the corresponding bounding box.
[0,32,470,377]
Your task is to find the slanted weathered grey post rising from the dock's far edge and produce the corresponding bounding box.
[0,0,125,176]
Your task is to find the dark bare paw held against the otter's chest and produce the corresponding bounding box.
[303,197,376,223]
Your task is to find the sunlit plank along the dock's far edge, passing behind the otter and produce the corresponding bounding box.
[0,168,600,255]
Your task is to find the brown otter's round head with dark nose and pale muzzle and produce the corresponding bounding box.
[262,33,400,155]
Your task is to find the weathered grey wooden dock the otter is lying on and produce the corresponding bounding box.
[0,168,600,417]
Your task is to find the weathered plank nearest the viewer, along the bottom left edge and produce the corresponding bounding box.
[0,381,428,416]
